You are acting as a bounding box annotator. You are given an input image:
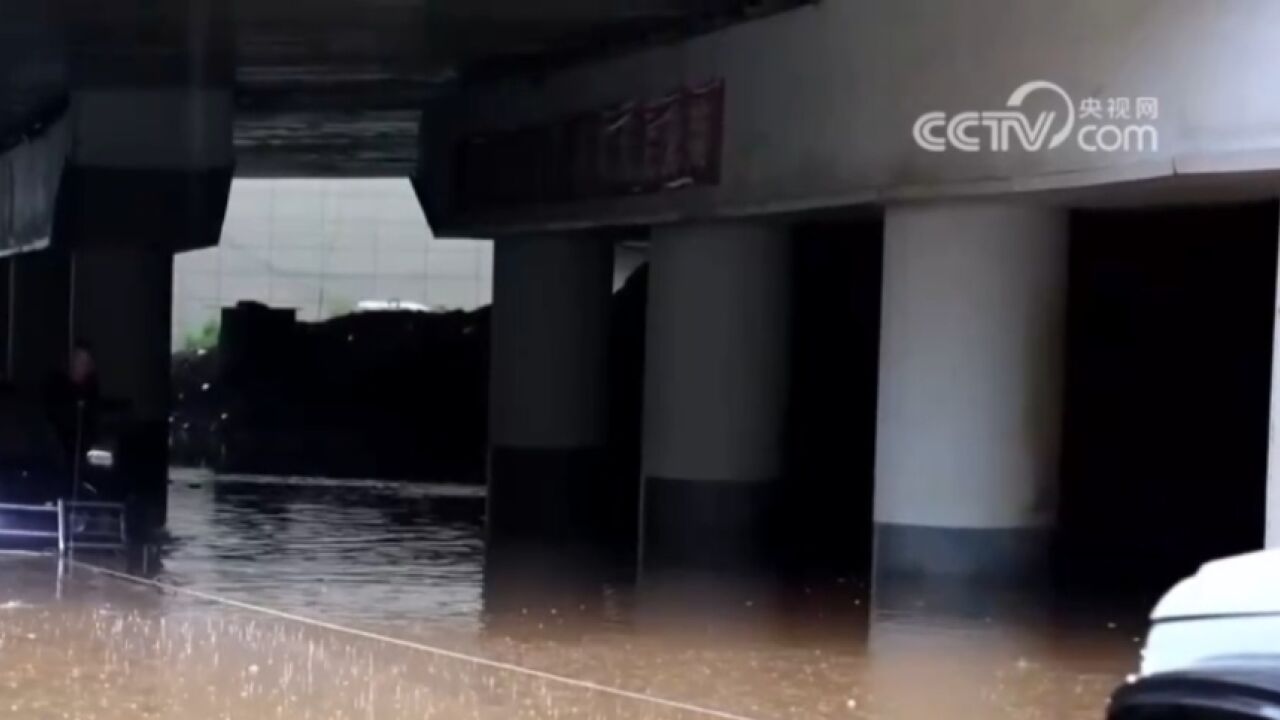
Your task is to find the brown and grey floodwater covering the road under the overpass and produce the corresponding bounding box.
[0,474,1142,720]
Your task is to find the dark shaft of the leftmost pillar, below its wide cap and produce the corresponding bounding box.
[72,246,173,525]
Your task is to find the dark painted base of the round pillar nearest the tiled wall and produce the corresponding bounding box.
[488,446,613,547]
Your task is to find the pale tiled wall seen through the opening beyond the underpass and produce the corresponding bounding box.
[173,179,493,348]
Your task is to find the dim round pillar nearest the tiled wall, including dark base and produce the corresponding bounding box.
[489,233,613,543]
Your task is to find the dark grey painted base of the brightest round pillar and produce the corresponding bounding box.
[872,523,1052,618]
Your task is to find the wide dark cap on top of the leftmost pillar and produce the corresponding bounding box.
[58,0,234,251]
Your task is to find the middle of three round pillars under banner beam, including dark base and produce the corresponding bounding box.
[641,222,790,571]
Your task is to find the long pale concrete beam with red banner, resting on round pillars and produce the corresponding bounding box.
[420,0,1280,234]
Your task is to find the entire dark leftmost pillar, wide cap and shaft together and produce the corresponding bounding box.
[56,0,234,527]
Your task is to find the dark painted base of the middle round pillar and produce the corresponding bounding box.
[641,477,777,575]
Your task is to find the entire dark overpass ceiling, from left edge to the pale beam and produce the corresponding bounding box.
[0,0,796,176]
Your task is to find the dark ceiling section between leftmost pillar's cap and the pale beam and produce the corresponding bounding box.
[236,0,773,176]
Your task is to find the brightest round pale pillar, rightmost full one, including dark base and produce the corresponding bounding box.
[876,204,1068,580]
